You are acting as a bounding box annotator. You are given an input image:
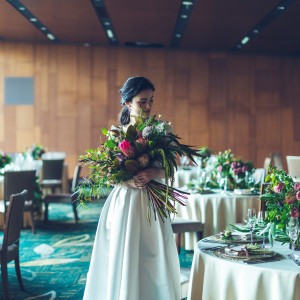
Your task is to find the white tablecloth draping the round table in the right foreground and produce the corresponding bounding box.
[188,241,300,300]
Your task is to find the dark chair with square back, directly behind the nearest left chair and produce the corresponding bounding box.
[4,170,36,234]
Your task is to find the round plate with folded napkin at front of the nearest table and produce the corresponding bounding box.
[213,246,276,261]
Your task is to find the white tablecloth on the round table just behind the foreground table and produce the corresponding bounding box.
[176,191,259,250]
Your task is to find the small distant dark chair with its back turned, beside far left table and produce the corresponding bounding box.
[40,158,64,194]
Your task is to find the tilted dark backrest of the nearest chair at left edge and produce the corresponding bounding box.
[2,190,28,251]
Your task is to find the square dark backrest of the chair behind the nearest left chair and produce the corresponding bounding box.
[4,170,36,201]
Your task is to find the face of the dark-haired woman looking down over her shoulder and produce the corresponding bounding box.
[126,89,154,117]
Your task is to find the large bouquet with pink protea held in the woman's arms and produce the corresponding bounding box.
[79,115,201,222]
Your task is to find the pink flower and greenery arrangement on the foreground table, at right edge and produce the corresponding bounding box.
[261,166,300,244]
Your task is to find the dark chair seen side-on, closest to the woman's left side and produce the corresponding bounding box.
[44,164,81,223]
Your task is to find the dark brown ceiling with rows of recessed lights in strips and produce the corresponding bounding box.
[0,0,300,55]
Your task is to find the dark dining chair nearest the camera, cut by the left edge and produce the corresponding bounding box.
[0,190,28,299]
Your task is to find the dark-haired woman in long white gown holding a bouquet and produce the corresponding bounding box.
[83,76,181,300]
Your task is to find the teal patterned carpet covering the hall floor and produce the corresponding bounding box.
[0,201,193,300]
